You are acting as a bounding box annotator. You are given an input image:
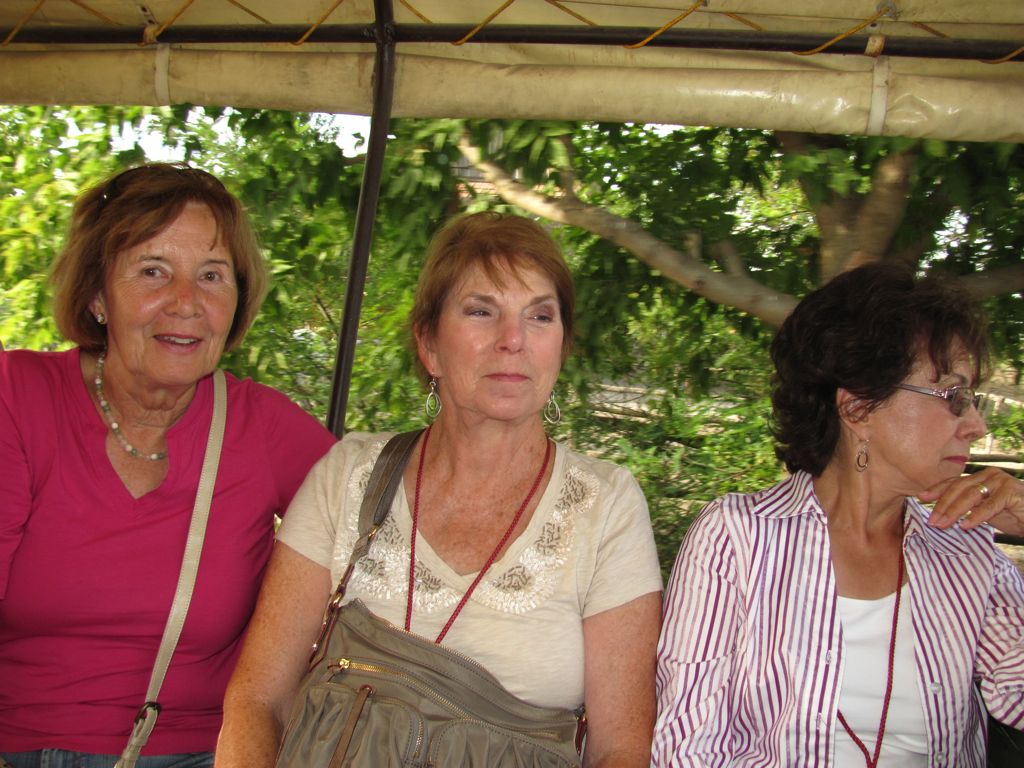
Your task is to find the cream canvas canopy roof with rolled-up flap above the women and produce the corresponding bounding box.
[0,0,1024,141]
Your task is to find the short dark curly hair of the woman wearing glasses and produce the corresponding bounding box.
[771,264,989,476]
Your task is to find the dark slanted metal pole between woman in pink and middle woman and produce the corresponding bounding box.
[327,0,395,437]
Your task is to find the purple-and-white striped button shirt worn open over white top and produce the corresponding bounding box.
[652,472,1024,768]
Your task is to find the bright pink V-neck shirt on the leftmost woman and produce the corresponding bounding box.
[0,350,334,755]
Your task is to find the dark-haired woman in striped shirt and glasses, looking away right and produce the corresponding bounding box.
[653,265,1024,768]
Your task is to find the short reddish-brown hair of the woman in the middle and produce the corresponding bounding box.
[410,211,575,380]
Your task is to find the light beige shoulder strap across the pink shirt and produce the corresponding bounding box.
[115,370,227,768]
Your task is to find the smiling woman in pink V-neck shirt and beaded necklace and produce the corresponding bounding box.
[0,164,334,768]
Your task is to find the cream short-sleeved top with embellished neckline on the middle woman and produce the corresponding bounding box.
[278,432,662,708]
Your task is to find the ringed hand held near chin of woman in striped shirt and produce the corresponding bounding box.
[918,467,1024,536]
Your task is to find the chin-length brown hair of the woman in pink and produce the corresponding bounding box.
[50,163,267,352]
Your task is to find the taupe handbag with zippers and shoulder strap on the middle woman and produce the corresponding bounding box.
[276,432,586,768]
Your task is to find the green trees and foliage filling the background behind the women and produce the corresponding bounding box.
[0,106,1024,577]
